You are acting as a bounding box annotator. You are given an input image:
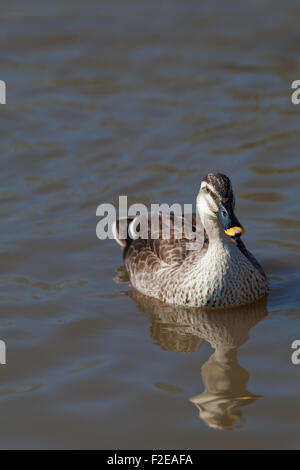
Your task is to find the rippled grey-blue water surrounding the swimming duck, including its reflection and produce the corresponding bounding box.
[0,0,300,449]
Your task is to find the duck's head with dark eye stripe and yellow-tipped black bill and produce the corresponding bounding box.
[197,173,245,237]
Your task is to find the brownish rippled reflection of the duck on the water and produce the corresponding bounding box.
[128,289,267,430]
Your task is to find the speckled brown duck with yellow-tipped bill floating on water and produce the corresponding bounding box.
[112,173,269,308]
